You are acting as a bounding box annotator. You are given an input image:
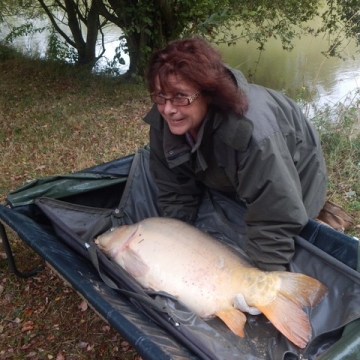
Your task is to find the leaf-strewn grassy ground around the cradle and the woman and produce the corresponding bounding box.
[0,48,360,360]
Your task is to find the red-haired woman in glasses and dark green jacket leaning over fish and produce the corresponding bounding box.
[144,38,326,270]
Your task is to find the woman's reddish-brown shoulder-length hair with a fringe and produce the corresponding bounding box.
[147,37,248,115]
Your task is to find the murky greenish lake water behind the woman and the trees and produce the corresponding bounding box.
[0,17,360,112]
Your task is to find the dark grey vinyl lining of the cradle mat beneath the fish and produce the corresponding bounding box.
[2,149,360,360]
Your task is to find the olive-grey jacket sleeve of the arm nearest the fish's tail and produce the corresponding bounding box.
[237,132,308,271]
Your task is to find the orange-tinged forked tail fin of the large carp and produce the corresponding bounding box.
[256,272,327,348]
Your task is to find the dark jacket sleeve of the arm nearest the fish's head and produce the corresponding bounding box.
[150,128,202,223]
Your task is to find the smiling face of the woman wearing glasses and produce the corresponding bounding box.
[154,75,208,139]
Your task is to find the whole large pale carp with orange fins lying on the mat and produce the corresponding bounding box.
[95,217,327,348]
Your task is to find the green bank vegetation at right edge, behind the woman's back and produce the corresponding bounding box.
[312,90,360,217]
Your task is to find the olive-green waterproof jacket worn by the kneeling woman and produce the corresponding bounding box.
[144,69,326,270]
